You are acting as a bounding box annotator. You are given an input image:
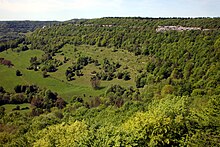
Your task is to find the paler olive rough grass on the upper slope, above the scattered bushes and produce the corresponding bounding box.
[57,45,147,82]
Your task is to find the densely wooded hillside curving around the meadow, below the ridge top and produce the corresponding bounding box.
[28,18,220,95]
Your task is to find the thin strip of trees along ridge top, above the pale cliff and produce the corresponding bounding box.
[91,17,220,29]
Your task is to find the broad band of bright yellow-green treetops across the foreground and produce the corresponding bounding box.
[8,94,215,146]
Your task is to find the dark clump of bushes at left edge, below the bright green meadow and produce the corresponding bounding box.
[0,85,67,115]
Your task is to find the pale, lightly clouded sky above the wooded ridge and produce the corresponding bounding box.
[0,0,220,21]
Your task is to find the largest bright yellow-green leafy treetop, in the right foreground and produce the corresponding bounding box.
[122,97,219,146]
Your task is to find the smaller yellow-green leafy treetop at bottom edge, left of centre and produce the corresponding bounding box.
[33,121,89,147]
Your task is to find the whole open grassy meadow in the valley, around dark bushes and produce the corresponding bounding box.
[0,45,148,101]
